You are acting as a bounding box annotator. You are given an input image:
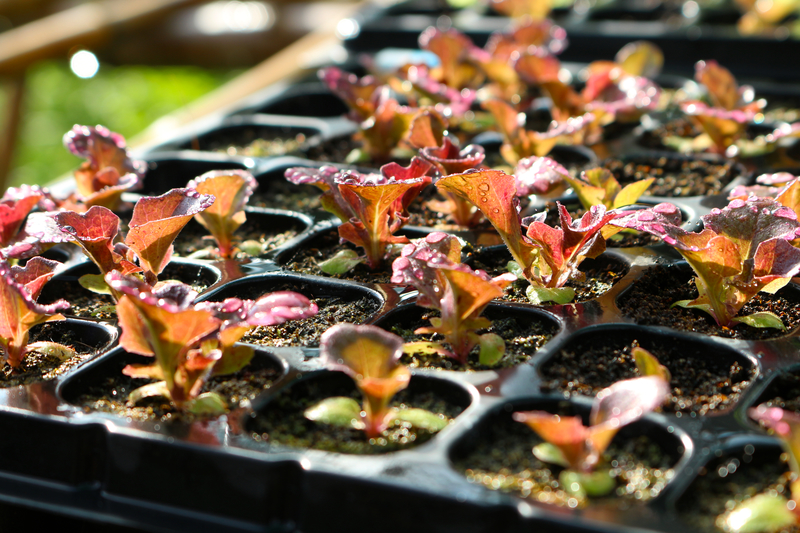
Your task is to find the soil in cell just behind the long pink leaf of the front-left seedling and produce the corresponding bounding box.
[242,297,380,347]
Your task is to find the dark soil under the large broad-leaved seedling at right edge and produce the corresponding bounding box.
[617,266,800,340]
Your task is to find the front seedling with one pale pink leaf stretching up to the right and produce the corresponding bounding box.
[514,376,670,500]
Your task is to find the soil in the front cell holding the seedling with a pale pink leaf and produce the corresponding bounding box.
[454,413,675,509]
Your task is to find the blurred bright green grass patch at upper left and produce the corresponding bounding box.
[5,61,236,185]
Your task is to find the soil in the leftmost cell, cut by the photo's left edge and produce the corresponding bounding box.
[0,321,100,388]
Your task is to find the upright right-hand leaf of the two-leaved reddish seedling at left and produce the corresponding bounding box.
[125,189,214,276]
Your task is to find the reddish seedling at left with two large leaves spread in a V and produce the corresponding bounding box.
[53,189,214,299]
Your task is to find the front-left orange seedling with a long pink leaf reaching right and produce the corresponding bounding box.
[106,271,317,414]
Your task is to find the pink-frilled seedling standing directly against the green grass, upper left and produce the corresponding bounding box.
[64,124,147,209]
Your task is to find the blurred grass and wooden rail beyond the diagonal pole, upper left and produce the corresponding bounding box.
[0,0,356,189]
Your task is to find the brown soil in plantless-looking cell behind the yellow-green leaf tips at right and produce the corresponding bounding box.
[603,156,738,198]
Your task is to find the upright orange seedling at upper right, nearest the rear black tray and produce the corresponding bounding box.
[681,61,764,154]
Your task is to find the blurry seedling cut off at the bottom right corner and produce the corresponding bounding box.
[722,404,800,533]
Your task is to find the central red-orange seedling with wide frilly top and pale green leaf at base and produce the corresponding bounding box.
[286,157,431,274]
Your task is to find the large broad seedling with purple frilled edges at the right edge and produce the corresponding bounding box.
[612,196,800,329]
